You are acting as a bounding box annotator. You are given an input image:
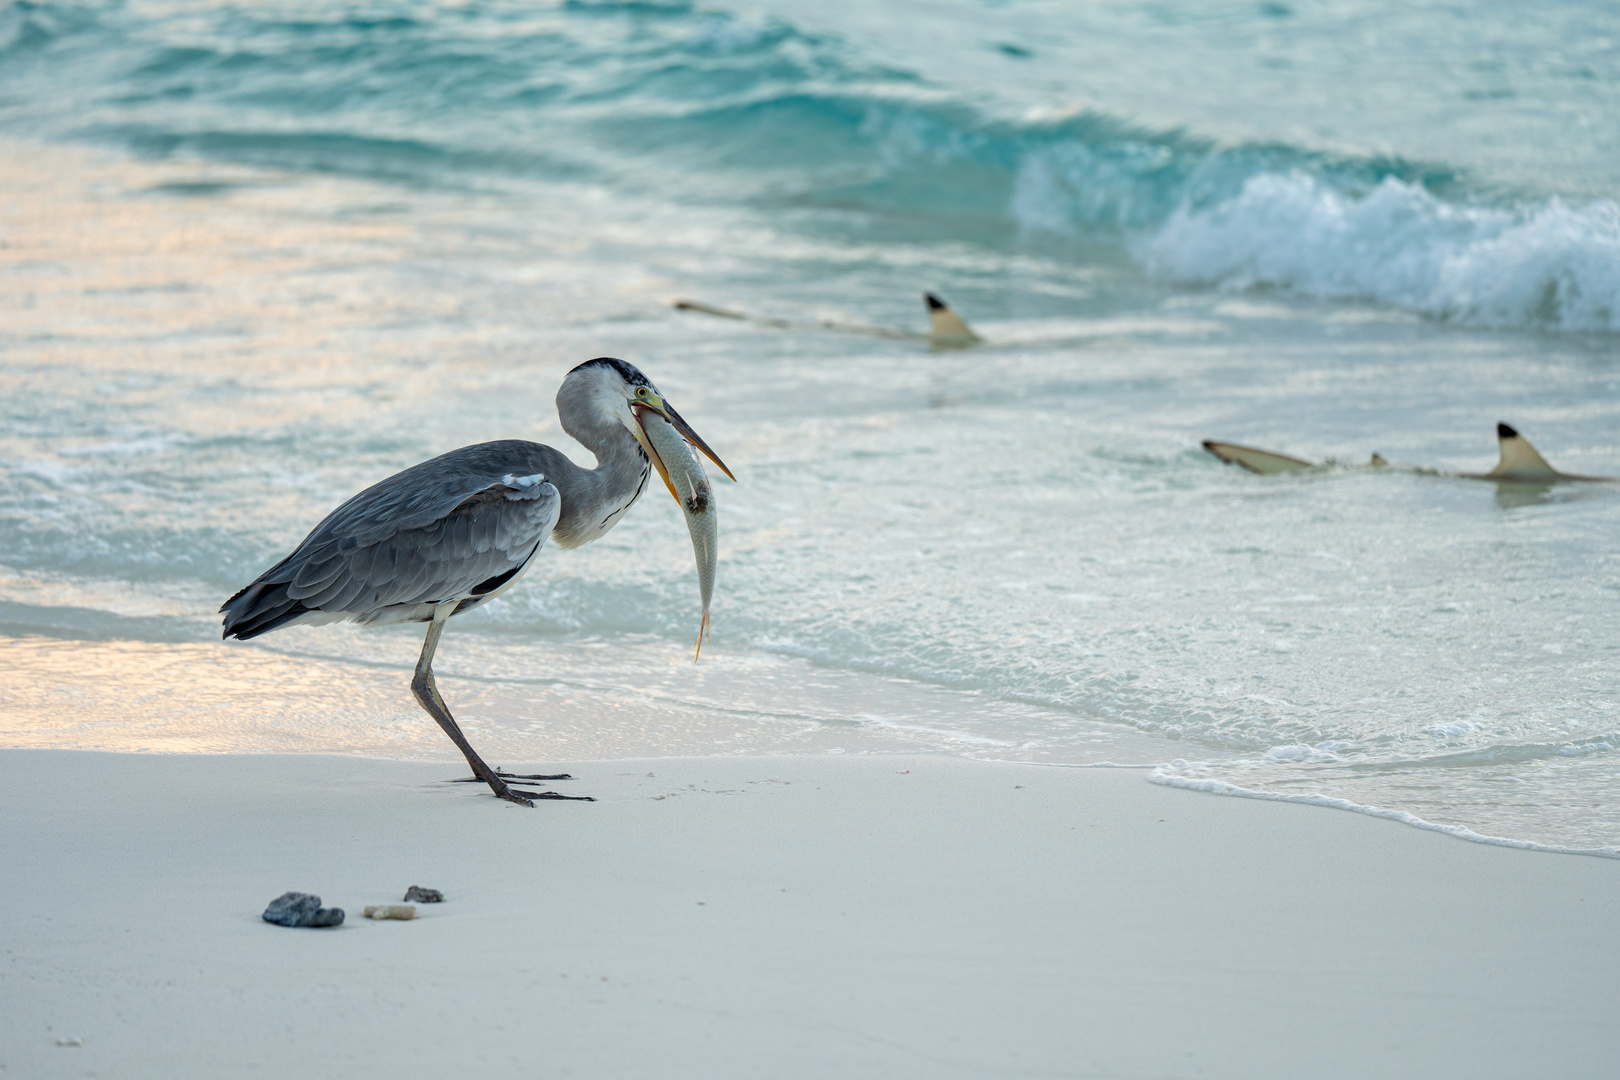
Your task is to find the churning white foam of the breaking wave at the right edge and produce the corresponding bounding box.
[1137,172,1620,330]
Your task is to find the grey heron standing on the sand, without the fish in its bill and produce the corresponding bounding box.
[220,356,735,806]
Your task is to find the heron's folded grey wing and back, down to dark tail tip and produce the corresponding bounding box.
[220,444,562,638]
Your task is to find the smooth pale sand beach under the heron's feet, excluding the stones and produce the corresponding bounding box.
[0,750,1620,1078]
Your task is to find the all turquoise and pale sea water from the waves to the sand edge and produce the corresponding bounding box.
[0,3,1620,848]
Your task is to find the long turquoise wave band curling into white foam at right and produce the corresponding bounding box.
[0,0,1620,332]
